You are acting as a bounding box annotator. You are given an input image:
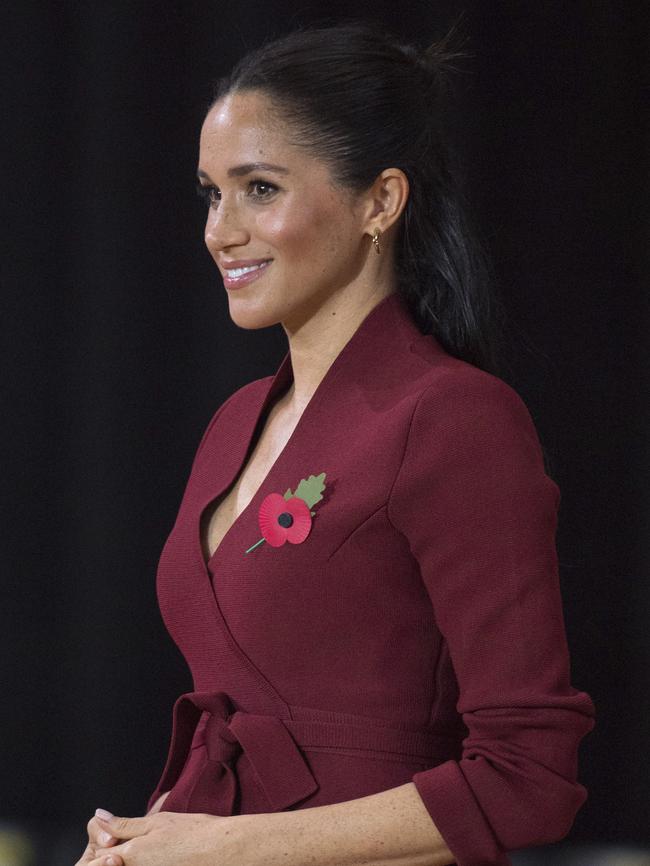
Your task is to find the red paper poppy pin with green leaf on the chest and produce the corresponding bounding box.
[245,472,325,553]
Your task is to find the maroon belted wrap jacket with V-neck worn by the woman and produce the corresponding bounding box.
[147,294,594,866]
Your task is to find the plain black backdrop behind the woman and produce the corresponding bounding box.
[0,0,650,843]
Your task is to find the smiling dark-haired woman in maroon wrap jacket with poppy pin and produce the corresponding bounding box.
[79,24,594,866]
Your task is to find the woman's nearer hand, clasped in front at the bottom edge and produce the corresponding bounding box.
[84,804,250,866]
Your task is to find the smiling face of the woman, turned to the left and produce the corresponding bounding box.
[198,91,369,332]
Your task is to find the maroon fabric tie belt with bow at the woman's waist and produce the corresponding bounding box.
[157,692,457,815]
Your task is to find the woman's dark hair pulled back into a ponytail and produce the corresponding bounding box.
[213,21,498,373]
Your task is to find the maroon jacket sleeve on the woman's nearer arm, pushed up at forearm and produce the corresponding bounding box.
[388,366,595,866]
